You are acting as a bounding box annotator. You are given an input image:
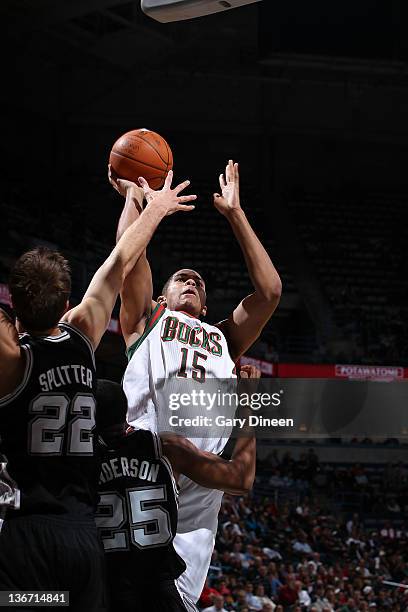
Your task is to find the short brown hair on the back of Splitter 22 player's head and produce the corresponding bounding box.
[9,247,71,331]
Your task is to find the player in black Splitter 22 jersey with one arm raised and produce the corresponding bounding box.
[0,179,196,612]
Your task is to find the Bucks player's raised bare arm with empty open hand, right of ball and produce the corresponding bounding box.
[214,160,282,360]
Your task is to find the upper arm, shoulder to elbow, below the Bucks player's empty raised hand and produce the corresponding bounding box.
[217,293,280,361]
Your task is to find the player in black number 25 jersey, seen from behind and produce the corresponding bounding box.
[96,380,256,612]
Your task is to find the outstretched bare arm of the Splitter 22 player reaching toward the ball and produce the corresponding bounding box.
[63,183,196,348]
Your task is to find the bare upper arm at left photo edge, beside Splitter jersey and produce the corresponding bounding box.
[0,308,25,399]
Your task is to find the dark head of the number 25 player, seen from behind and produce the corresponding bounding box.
[96,378,127,431]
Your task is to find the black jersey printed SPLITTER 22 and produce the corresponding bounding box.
[0,323,100,518]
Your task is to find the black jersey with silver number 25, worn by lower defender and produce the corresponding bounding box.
[96,428,186,596]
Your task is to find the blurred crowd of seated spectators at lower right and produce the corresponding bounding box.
[199,451,408,612]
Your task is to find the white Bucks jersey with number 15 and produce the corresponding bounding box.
[123,304,236,454]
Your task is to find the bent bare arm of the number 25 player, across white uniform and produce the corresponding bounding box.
[160,434,256,495]
